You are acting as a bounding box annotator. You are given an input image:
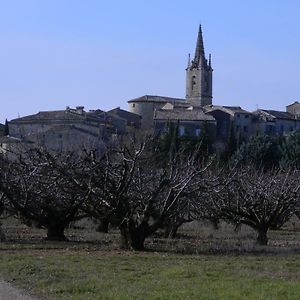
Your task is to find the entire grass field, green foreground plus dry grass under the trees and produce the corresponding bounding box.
[0,219,300,300]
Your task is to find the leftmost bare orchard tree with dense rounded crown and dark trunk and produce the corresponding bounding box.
[0,149,87,240]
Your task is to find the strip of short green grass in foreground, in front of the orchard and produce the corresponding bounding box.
[0,250,300,300]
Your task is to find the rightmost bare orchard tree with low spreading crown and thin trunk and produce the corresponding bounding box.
[205,168,300,245]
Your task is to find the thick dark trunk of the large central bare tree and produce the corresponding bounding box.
[120,221,148,251]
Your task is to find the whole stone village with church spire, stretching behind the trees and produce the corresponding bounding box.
[0,26,300,152]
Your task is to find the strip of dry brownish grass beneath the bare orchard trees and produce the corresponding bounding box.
[0,214,300,254]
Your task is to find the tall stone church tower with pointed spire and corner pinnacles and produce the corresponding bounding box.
[186,25,213,106]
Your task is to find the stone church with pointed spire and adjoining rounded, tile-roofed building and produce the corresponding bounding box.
[128,25,216,135]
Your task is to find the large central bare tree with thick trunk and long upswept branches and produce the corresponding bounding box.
[84,139,213,250]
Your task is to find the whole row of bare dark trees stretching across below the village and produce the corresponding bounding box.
[0,133,300,250]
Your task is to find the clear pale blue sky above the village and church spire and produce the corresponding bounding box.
[0,0,300,123]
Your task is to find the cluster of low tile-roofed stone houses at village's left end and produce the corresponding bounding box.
[9,106,126,151]
